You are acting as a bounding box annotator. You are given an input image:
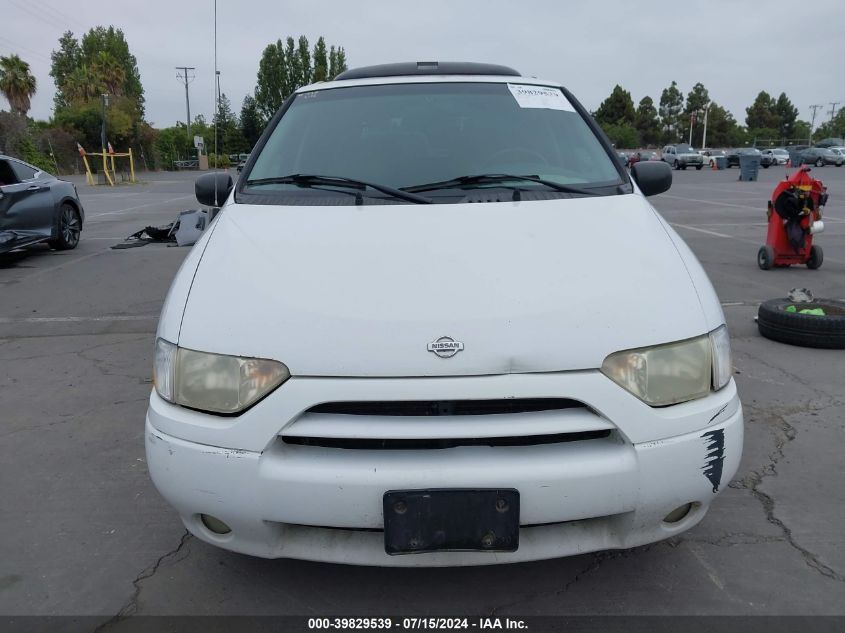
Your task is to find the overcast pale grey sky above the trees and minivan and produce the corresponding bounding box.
[0,0,845,127]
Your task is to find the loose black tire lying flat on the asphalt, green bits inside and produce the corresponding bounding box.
[757,299,845,349]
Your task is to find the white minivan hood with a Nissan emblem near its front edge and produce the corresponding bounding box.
[178,194,707,376]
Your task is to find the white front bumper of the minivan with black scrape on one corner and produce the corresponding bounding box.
[145,372,743,566]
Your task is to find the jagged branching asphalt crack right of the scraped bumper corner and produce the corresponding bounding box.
[728,405,845,582]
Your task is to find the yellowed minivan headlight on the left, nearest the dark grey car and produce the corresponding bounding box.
[153,338,290,414]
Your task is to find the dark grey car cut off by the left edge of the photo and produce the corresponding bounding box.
[0,154,85,253]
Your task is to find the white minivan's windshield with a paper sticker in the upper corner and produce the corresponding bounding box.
[239,82,630,204]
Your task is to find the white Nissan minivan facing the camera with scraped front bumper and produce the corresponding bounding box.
[145,63,743,566]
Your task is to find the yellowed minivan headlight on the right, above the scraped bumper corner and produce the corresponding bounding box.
[601,325,732,407]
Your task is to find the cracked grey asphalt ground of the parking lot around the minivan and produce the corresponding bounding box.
[0,167,845,630]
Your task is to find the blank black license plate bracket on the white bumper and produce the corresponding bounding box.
[383,488,519,555]
